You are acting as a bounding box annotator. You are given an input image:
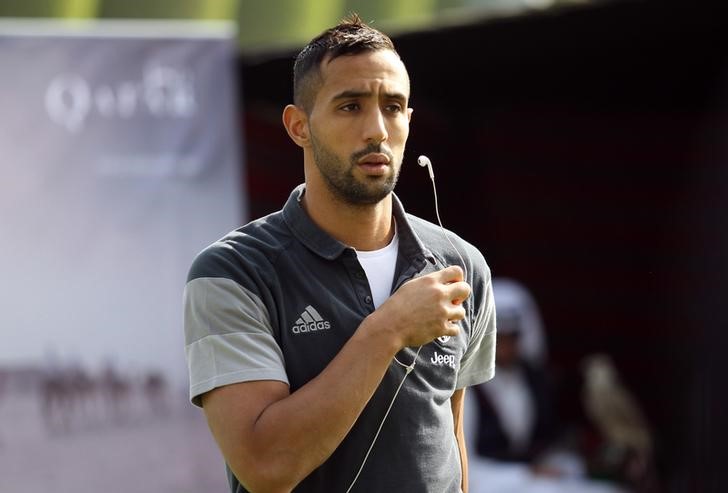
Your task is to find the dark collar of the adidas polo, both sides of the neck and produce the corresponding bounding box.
[283,184,434,261]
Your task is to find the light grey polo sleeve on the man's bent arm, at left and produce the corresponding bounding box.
[184,270,288,407]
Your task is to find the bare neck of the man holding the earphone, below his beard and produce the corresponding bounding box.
[301,184,394,251]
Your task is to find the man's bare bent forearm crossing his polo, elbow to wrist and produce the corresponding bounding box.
[205,314,399,492]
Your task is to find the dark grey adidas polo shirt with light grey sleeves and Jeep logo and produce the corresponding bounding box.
[184,185,495,493]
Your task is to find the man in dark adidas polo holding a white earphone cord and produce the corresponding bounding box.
[185,16,495,493]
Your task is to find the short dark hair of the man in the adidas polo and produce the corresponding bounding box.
[293,13,397,113]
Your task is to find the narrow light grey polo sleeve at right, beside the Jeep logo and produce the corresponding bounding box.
[455,248,496,389]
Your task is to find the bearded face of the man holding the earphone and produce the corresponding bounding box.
[308,50,412,205]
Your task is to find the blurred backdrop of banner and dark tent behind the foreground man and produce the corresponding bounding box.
[0,0,728,493]
